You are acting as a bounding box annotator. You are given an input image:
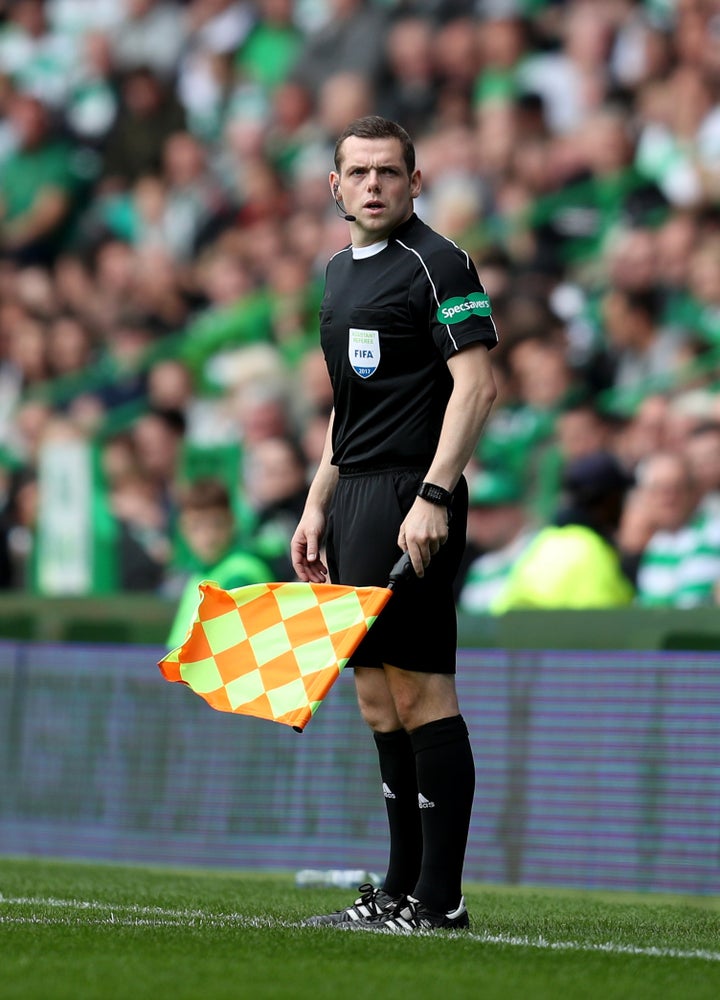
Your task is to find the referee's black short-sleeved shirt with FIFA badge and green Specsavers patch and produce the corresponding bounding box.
[320,215,497,469]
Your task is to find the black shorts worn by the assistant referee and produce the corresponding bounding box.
[326,469,467,674]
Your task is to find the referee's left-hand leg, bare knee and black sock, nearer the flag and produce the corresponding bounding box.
[355,667,423,897]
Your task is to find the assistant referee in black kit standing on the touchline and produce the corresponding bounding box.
[291,116,497,932]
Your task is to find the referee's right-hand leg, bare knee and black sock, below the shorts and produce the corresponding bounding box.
[385,667,475,913]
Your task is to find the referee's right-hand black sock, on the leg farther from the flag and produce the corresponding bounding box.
[410,715,475,913]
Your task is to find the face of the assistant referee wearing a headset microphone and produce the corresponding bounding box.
[330,136,421,246]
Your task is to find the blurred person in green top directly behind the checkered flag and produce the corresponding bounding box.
[166,479,272,649]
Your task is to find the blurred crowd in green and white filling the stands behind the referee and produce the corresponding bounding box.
[0,0,720,612]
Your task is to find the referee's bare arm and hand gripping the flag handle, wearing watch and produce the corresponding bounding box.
[398,344,497,576]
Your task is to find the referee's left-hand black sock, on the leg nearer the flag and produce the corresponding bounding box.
[373,729,422,896]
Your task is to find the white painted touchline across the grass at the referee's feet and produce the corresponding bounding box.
[0,895,720,962]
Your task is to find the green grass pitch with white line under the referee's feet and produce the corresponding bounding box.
[0,859,720,1000]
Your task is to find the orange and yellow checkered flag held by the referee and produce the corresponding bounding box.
[158,581,392,732]
